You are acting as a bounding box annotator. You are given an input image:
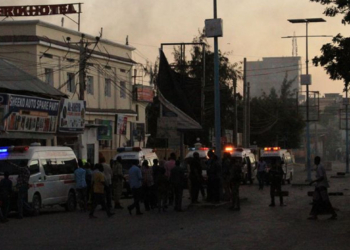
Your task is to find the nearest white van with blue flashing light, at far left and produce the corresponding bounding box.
[0,146,78,213]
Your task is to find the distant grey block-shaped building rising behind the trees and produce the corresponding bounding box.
[247,57,301,98]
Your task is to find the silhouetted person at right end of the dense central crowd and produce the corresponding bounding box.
[228,158,243,211]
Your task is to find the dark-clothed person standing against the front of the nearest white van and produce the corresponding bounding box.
[17,165,32,219]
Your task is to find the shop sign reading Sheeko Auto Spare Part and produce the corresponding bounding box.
[0,94,59,133]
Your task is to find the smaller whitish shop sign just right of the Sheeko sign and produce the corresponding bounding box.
[58,99,86,133]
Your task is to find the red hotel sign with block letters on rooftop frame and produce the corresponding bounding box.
[0,3,80,17]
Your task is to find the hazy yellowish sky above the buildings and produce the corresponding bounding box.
[1,0,350,94]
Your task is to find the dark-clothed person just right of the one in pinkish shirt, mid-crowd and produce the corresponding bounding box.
[170,160,185,212]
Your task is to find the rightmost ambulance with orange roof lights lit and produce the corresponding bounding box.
[260,147,294,184]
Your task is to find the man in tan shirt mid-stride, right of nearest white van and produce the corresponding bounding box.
[89,163,114,219]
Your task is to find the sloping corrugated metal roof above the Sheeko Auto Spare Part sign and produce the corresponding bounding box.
[0,59,68,99]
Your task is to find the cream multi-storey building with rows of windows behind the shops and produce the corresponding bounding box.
[0,20,150,162]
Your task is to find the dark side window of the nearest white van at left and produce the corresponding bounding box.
[41,158,77,175]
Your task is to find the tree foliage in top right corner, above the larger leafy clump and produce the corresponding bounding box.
[310,0,350,25]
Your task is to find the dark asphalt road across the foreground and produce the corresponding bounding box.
[0,163,350,250]
